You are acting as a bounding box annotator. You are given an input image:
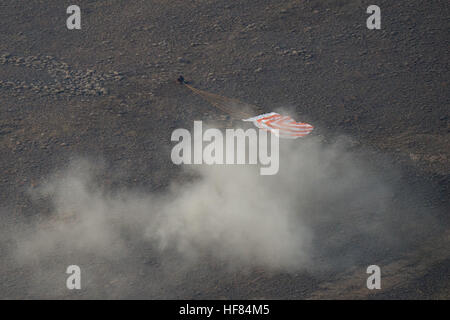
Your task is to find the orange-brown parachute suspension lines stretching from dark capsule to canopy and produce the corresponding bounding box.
[184,83,253,118]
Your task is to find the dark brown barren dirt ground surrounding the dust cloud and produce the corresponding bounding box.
[0,0,450,299]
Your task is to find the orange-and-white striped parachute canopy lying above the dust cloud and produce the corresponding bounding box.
[243,112,314,139]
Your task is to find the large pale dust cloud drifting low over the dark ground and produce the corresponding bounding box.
[0,129,436,297]
